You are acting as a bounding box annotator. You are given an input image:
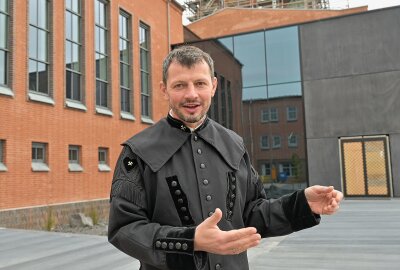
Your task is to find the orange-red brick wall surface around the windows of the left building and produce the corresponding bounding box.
[0,0,183,209]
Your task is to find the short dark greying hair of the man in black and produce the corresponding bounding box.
[163,45,214,84]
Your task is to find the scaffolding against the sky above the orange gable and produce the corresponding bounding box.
[185,0,329,22]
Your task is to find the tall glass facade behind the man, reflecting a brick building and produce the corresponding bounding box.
[183,26,307,197]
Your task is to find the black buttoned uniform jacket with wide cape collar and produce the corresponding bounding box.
[108,116,320,270]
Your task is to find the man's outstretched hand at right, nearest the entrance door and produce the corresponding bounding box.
[304,186,343,215]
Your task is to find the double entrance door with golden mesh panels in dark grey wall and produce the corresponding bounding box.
[340,136,391,197]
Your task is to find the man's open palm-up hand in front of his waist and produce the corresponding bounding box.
[194,208,261,255]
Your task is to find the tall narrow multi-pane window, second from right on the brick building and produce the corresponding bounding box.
[119,10,133,114]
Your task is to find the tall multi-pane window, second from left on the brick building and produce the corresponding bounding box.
[29,0,50,95]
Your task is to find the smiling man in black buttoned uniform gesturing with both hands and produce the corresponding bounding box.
[108,46,343,270]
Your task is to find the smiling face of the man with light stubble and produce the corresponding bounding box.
[160,61,217,128]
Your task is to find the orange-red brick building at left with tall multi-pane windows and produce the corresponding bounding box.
[0,0,183,227]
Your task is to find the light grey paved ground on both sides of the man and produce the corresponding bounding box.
[0,199,400,270]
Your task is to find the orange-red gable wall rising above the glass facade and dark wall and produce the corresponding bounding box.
[187,6,368,41]
